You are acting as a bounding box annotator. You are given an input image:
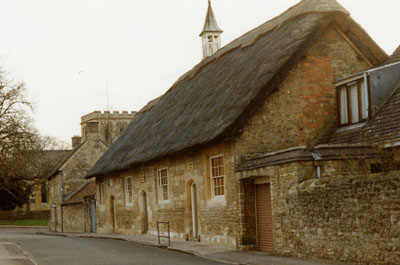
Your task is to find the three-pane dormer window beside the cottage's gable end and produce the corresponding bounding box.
[338,79,368,125]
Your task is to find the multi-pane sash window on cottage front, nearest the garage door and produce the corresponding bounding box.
[210,155,225,197]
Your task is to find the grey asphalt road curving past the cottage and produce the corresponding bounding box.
[0,228,225,265]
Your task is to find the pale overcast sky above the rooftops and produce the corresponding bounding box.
[0,0,400,142]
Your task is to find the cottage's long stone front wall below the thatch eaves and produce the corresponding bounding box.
[96,143,240,247]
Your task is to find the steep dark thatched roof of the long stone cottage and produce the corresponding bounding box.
[87,0,387,178]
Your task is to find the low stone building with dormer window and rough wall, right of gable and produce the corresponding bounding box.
[236,47,400,264]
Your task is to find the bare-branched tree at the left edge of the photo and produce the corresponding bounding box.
[0,69,66,210]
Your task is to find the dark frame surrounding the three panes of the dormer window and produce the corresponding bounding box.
[336,77,371,127]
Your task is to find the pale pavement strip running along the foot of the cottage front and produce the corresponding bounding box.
[36,230,345,265]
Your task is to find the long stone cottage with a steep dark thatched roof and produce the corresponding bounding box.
[87,0,388,260]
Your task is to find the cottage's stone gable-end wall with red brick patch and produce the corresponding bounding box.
[235,27,368,163]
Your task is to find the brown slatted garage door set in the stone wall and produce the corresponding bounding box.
[256,184,274,252]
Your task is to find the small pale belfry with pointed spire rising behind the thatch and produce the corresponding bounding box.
[200,0,222,58]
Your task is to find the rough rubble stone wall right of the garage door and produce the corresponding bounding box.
[277,172,400,264]
